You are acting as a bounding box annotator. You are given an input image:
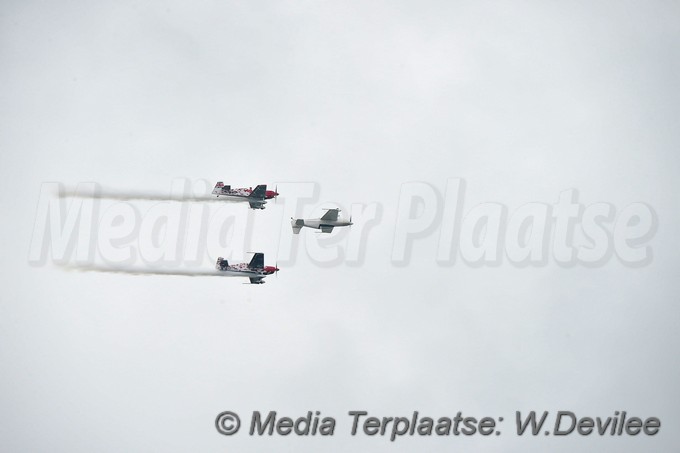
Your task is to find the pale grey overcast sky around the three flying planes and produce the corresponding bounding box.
[0,0,680,452]
